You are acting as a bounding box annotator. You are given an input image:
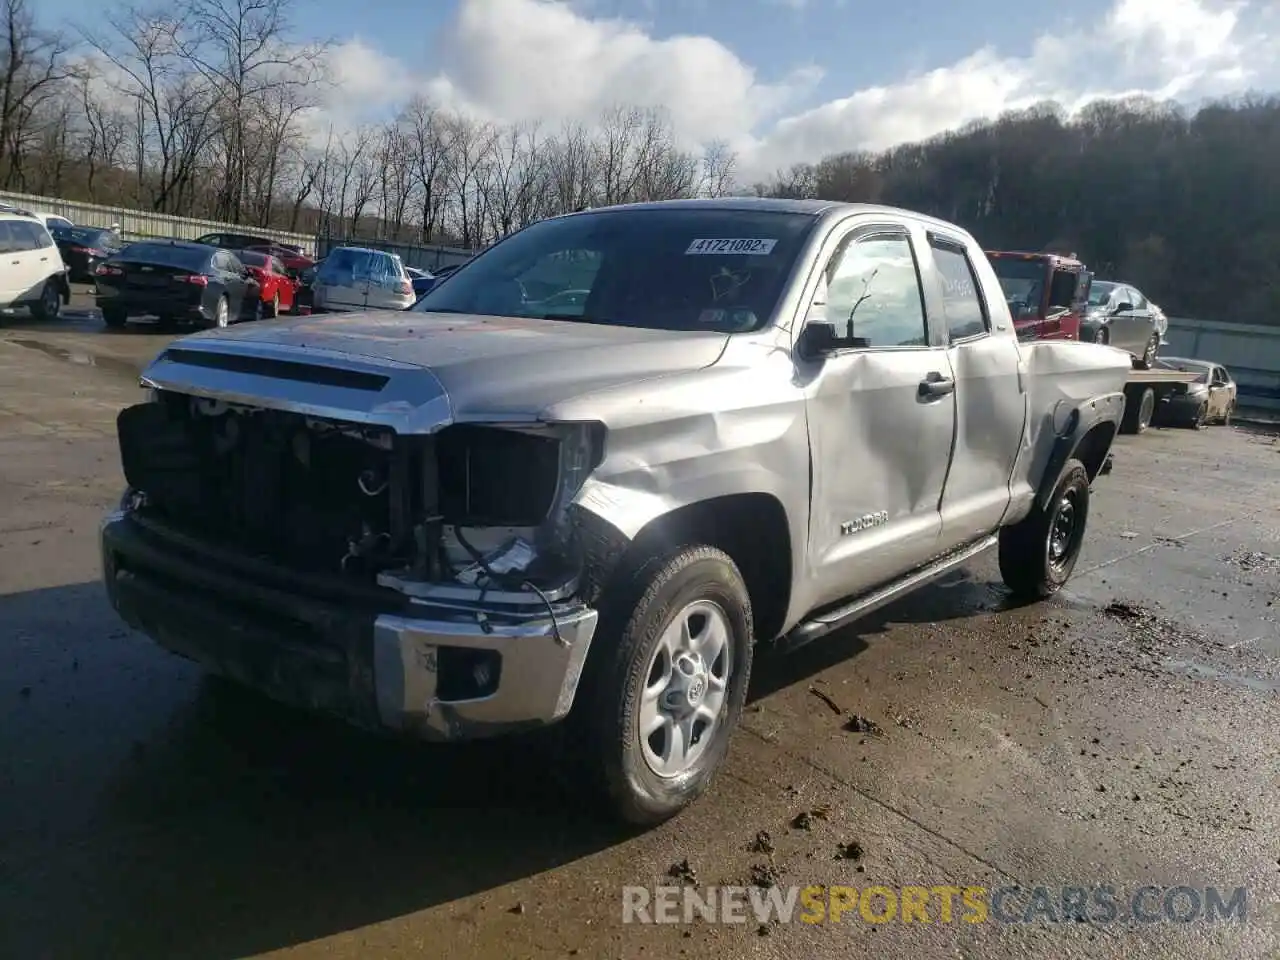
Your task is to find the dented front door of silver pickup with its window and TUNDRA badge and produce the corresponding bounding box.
[799,223,955,605]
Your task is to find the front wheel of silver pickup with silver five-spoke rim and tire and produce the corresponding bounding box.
[570,547,753,827]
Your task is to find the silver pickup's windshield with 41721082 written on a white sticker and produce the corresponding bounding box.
[412,207,815,333]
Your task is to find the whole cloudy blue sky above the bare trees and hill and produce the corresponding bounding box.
[33,0,1280,174]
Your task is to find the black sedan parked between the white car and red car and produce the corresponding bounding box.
[93,241,262,328]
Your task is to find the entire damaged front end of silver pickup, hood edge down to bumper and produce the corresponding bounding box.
[101,340,624,740]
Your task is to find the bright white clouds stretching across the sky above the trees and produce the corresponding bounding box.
[307,0,1280,175]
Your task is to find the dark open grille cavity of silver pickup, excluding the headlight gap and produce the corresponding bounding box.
[118,396,420,576]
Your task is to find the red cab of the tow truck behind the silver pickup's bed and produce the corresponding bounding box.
[987,250,1093,340]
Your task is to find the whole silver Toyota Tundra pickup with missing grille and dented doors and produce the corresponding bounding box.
[101,198,1129,824]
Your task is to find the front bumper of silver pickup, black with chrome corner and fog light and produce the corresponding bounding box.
[100,512,598,741]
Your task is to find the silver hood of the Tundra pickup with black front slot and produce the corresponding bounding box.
[142,311,728,433]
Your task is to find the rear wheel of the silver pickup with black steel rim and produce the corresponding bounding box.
[1000,460,1089,599]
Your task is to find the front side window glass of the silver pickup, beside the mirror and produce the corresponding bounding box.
[824,233,928,347]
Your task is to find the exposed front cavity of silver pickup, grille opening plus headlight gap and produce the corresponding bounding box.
[118,392,602,589]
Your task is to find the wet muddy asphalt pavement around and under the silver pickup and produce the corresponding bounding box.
[0,303,1280,960]
